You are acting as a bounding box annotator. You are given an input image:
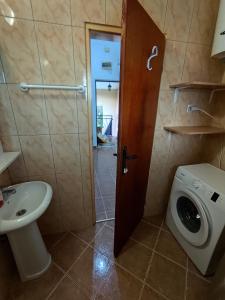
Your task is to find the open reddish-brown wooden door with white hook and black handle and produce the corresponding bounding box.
[114,0,165,256]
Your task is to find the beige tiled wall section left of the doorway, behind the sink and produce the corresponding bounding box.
[0,0,121,232]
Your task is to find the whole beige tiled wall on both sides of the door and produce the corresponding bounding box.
[0,0,222,232]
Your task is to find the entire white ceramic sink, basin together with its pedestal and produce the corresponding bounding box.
[0,181,52,281]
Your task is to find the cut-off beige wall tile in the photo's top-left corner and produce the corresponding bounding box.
[0,0,32,19]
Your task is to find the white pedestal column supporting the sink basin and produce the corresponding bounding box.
[7,222,51,281]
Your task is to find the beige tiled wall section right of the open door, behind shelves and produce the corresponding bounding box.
[142,0,224,215]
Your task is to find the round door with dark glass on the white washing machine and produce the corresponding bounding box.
[170,190,210,247]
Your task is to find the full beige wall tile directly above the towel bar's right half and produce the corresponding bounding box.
[35,22,74,84]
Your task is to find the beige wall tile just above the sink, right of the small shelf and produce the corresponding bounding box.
[20,135,53,176]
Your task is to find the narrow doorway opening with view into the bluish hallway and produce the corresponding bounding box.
[87,24,121,222]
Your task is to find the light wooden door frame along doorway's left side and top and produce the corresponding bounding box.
[85,23,122,224]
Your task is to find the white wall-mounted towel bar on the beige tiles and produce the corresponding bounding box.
[19,82,85,93]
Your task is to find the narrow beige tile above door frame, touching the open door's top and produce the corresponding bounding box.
[106,0,122,26]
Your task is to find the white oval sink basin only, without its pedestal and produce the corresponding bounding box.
[0,181,52,233]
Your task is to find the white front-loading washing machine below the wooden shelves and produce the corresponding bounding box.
[166,164,225,275]
